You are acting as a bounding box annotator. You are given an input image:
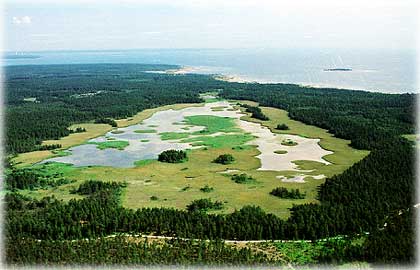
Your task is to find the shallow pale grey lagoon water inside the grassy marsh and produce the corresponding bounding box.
[43,101,332,171]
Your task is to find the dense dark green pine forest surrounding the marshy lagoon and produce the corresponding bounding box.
[4,65,417,264]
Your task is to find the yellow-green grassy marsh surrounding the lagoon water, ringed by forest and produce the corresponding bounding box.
[11,98,368,218]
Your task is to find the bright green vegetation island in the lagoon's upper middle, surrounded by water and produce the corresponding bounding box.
[185,115,241,134]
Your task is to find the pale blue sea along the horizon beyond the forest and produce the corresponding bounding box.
[2,48,419,93]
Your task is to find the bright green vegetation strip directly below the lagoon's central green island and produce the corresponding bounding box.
[181,133,254,148]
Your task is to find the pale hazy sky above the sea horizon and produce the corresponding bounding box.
[1,0,419,52]
